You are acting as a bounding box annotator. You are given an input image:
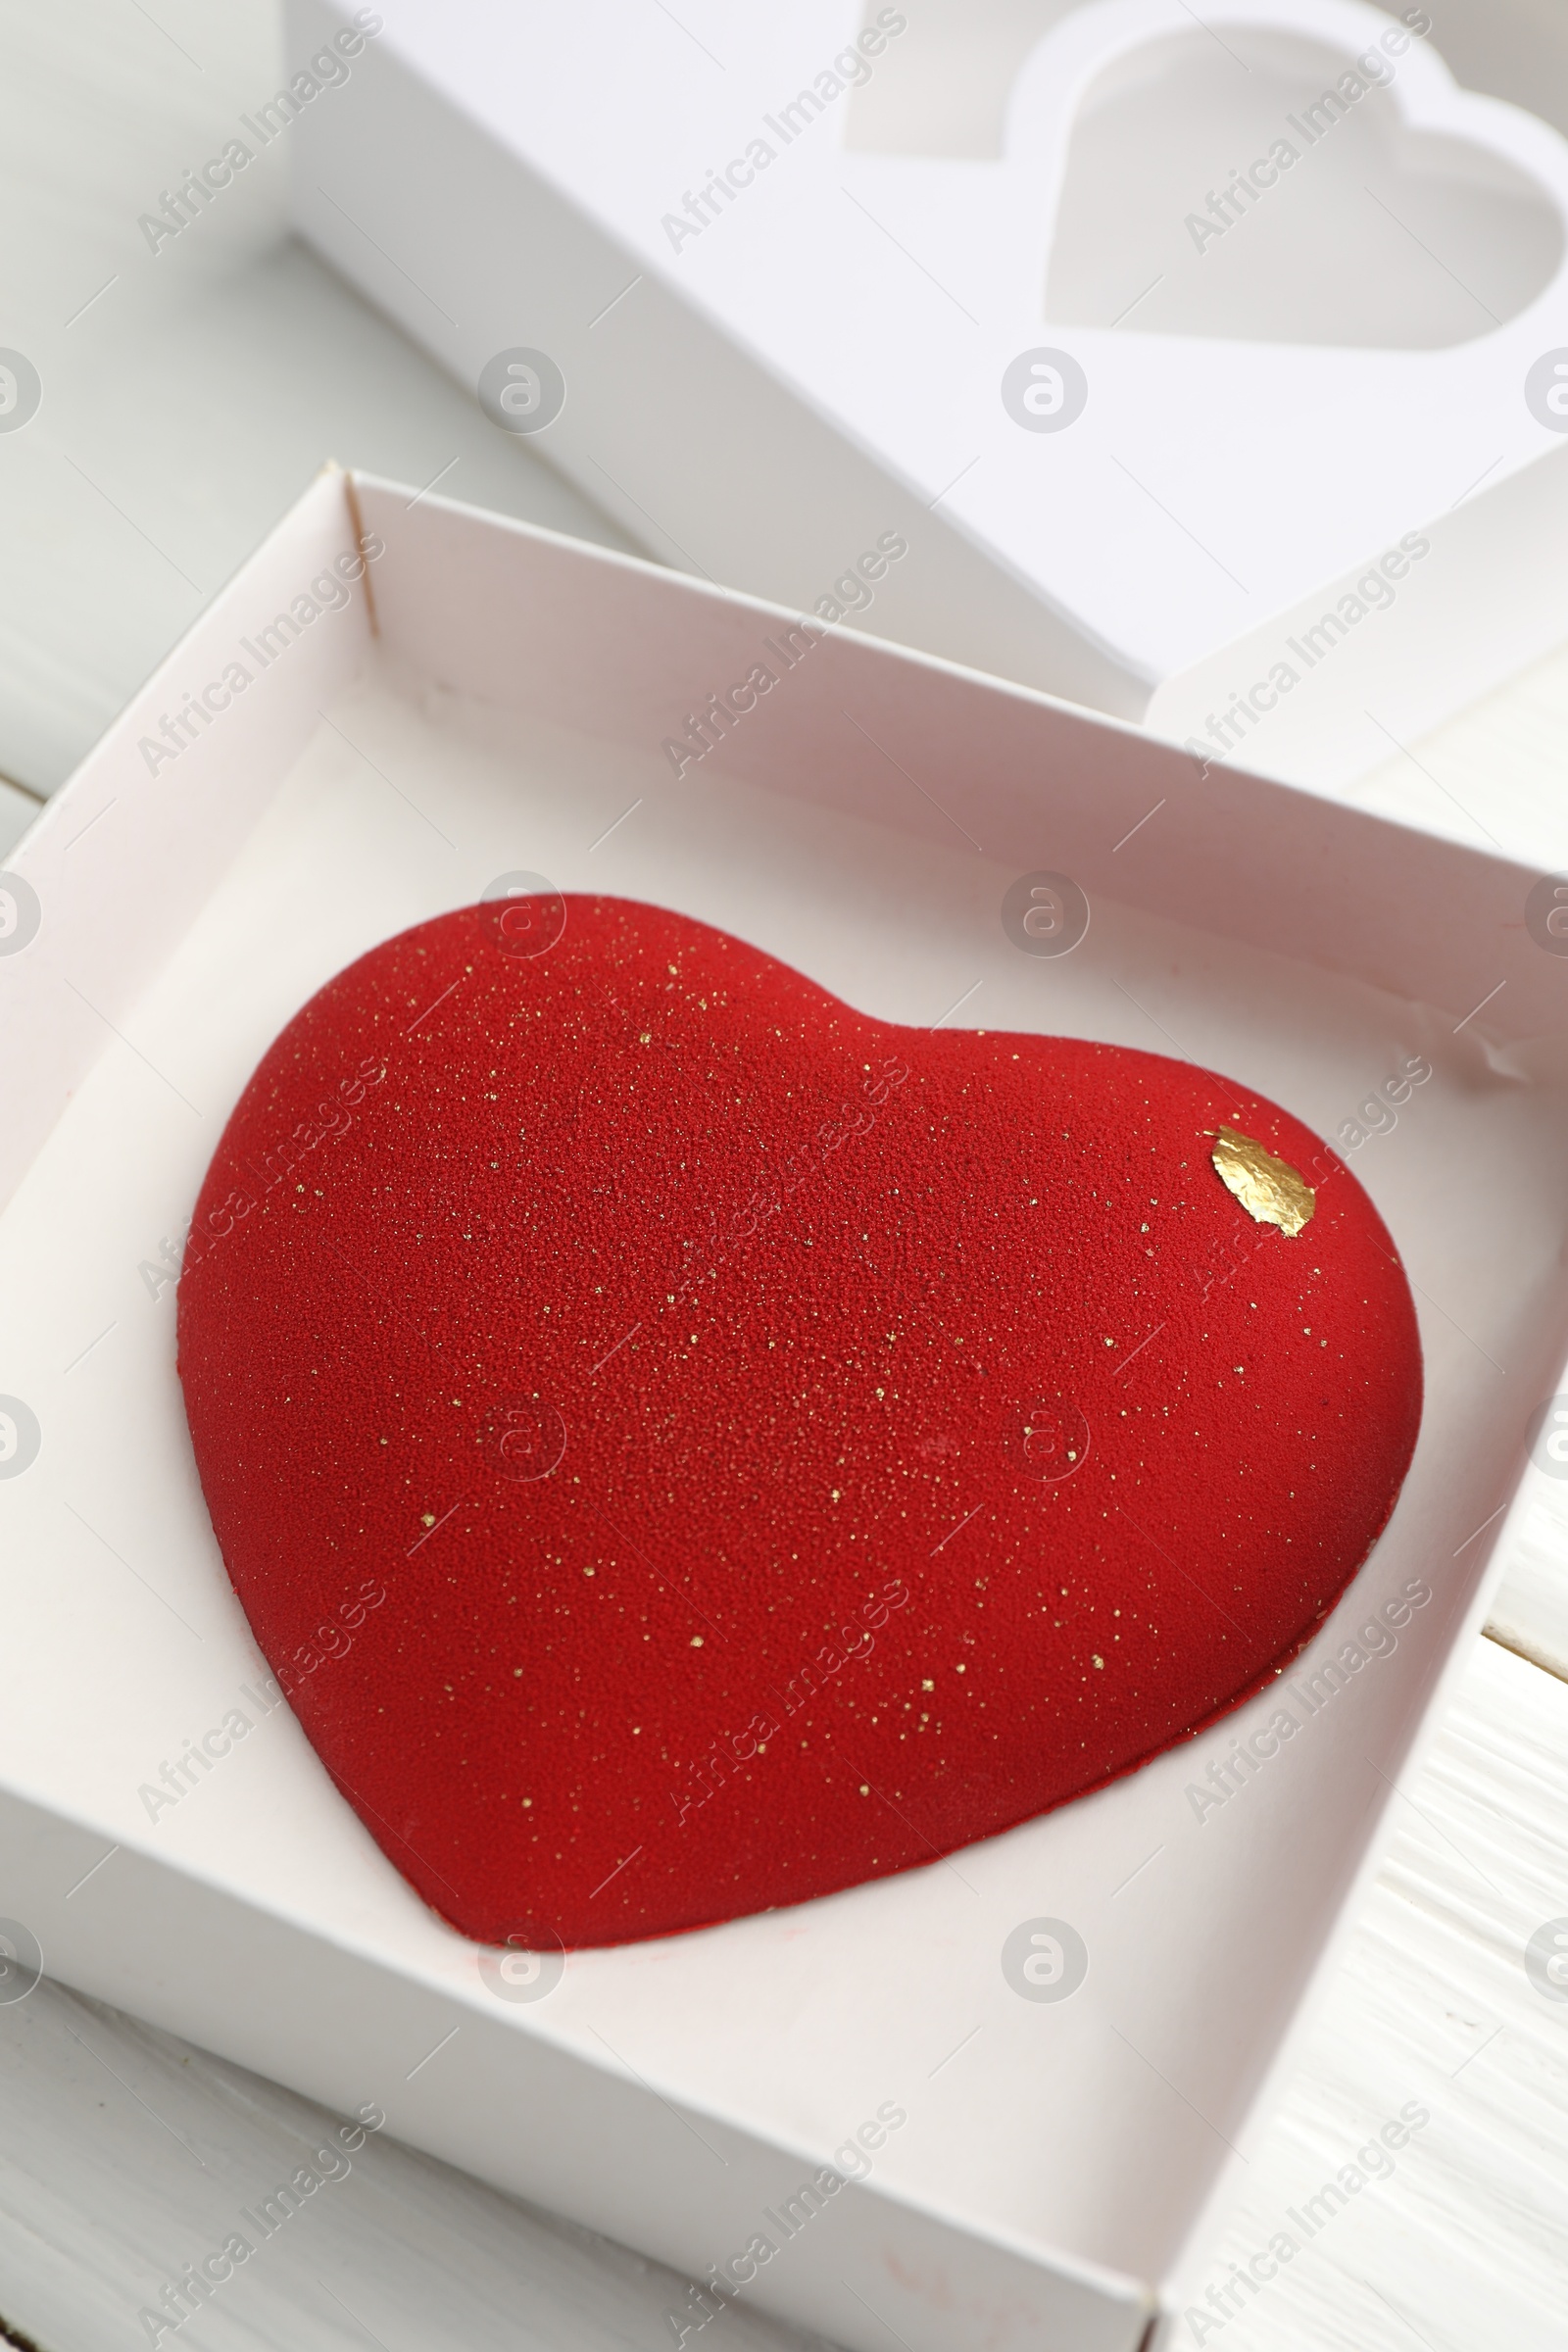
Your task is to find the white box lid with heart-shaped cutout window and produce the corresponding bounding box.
[282,0,1568,783]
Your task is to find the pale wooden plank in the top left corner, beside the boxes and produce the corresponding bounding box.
[0,0,630,793]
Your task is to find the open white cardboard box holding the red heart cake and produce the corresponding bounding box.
[0,475,1568,2352]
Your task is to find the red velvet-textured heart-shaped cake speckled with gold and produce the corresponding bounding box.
[178,899,1420,1945]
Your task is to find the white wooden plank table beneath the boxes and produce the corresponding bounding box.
[0,0,1568,2352]
